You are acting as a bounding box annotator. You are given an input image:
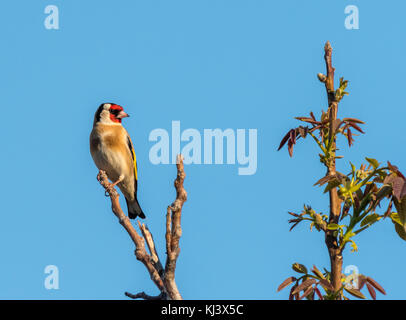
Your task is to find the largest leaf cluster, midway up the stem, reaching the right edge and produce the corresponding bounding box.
[288,158,406,252]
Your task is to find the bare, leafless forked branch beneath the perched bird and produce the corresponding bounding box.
[97,155,187,300]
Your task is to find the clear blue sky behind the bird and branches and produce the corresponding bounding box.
[0,0,406,299]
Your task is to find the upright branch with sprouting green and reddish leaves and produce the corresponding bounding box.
[278,42,406,300]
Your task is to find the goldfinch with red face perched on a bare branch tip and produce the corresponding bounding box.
[90,103,145,219]
